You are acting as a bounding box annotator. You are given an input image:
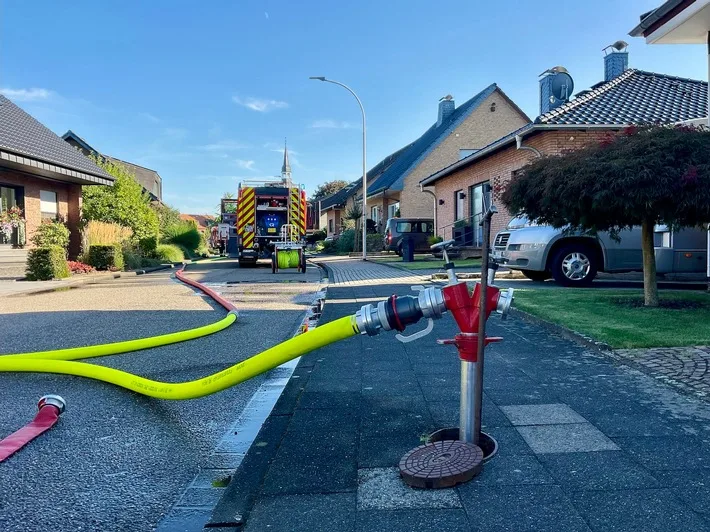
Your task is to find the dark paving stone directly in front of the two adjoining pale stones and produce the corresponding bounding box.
[538,451,658,490]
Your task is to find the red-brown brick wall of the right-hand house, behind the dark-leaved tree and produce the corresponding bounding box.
[435,130,608,238]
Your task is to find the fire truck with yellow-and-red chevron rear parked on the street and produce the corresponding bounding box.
[237,175,307,267]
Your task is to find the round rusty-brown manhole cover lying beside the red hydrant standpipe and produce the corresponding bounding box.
[399,440,483,489]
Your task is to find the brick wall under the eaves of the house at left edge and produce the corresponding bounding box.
[0,168,81,258]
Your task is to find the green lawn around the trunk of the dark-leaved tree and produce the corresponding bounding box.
[514,288,710,349]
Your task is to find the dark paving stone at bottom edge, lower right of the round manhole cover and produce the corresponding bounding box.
[459,483,590,532]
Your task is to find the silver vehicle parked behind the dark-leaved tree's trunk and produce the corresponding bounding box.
[493,217,707,286]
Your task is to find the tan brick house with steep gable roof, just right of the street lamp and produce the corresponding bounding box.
[346,83,530,231]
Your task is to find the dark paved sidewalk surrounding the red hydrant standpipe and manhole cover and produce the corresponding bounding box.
[212,262,710,532]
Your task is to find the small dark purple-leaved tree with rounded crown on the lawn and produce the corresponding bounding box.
[501,126,710,306]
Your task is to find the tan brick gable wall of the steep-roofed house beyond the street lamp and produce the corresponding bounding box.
[400,91,527,218]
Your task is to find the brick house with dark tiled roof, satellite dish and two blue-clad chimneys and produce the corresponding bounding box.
[421,43,708,242]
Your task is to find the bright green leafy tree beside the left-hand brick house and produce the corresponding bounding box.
[82,156,158,239]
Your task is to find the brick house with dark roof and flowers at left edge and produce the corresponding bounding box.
[0,96,113,269]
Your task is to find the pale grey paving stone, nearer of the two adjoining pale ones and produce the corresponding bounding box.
[517,423,619,453]
